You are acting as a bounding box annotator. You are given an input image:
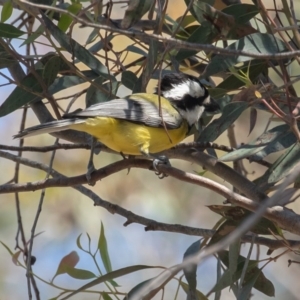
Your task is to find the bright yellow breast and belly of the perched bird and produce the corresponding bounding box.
[71,117,188,155]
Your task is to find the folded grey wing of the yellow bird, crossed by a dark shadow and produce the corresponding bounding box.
[64,97,183,129]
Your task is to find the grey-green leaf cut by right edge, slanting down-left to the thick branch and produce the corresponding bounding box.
[256,143,300,190]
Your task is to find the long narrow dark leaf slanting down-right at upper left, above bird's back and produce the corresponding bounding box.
[41,13,112,79]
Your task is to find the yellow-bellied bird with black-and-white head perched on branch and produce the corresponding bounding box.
[14,72,220,179]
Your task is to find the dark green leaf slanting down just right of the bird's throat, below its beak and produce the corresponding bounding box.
[198,102,248,143]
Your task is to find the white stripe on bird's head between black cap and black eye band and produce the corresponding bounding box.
[163,80,205,100]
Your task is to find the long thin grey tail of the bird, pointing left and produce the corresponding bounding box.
[14,119,85,139]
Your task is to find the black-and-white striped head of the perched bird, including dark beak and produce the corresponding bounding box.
[160,73,220,126]
